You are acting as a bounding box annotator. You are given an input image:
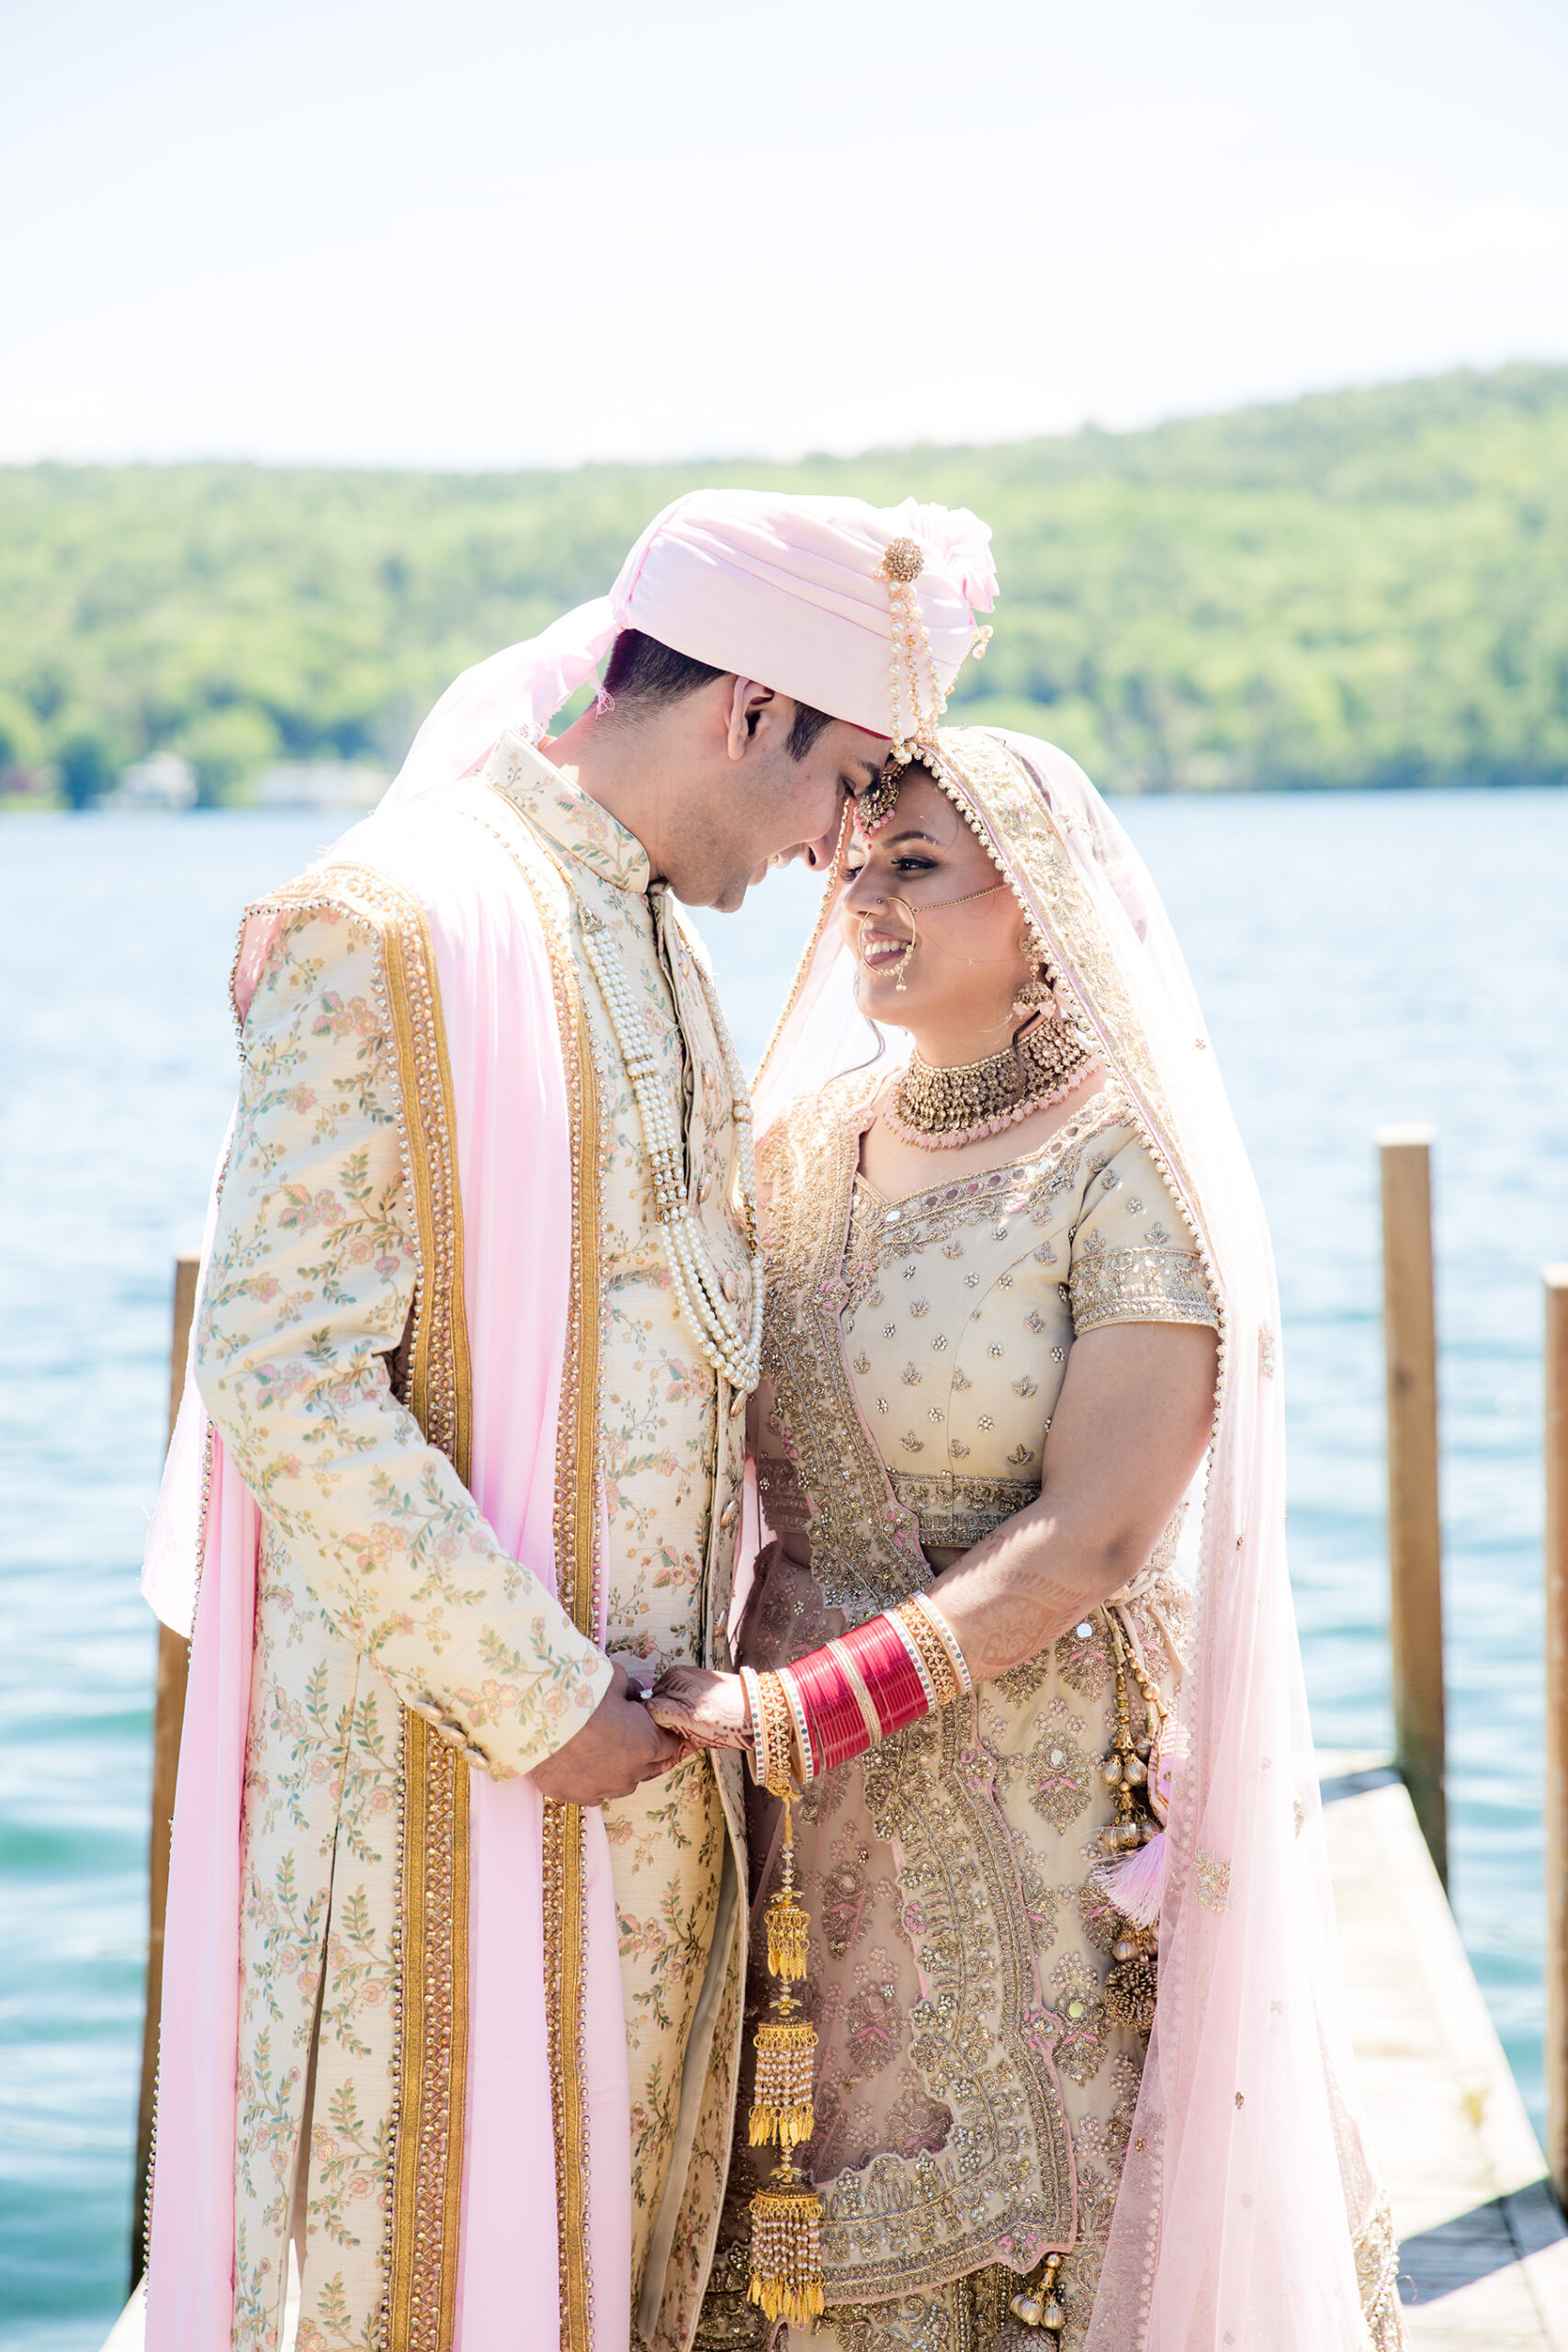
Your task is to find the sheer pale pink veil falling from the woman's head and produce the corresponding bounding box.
[757,729,1401,2352]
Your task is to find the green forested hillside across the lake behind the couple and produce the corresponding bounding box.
[0,367,1568,799]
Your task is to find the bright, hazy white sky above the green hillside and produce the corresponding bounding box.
[0,0,1568,468]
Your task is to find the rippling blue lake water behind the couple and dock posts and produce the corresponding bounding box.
[0,793,1568,2352]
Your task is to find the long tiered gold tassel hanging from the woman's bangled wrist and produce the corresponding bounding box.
[750,1794,828,2326]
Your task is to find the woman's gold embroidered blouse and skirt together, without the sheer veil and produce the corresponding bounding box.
[710,1080,1215,2352]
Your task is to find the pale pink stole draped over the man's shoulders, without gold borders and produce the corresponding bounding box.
[146,786,630,2352]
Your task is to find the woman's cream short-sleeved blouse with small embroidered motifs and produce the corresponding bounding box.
[760,1089,1218,1550]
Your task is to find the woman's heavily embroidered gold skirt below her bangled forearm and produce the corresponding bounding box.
[696,1550,1185,2352]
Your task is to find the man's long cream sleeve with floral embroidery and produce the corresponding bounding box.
[195,908,611,1778]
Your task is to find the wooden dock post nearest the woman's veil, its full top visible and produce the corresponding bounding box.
[1378,1126,1448,1886]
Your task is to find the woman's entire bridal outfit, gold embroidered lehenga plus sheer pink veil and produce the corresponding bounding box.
[698,734,1401,2352]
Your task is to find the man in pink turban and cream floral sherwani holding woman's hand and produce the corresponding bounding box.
[148,492,989,2352]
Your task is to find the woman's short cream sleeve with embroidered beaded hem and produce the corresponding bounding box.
[1067,1136,1220,1339]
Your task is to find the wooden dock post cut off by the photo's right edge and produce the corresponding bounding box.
[1544,1265,1568,2204]
